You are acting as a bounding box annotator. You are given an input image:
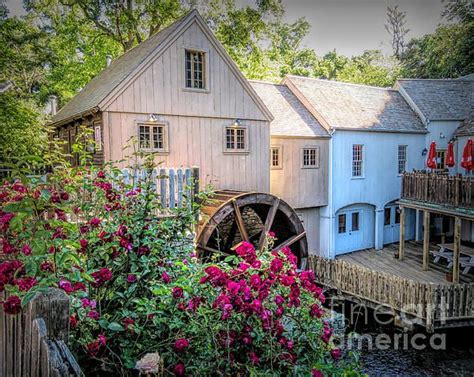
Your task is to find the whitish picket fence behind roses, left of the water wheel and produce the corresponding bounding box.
[122,167,199,208]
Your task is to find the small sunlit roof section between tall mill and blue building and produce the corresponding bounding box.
[250,80,329,137]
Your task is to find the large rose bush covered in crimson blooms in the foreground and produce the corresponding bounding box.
[0,158,355,376]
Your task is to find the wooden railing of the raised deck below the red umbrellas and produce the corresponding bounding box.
[401,173,474,208]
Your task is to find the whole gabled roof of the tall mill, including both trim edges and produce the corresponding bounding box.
[51,10,272,124]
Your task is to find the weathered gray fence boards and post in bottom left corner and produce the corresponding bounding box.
[0,289,82,377]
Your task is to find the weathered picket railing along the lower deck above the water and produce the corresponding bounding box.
[309,256,474,331]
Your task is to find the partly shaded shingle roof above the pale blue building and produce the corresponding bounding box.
[284,76,426,132]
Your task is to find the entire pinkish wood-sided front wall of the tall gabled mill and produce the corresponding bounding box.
[103,22,270,192]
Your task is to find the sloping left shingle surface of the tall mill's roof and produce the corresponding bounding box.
[51,12,194,124]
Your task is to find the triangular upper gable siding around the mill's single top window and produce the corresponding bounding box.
[104,22,266,120]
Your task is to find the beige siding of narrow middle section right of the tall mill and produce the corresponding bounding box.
[270,136,329,208]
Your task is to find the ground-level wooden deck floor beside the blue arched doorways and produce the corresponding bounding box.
[337,241,474,284]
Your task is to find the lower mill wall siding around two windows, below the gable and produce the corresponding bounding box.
[104,112,270,192]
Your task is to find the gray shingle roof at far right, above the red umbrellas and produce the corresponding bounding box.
[396,79,474,120]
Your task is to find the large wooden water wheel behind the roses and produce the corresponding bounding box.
[197,190,308,268]
